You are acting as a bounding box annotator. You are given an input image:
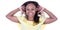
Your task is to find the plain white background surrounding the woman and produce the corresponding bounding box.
[0,0,60,30]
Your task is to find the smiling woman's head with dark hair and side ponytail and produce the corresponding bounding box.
[22,1,39,22]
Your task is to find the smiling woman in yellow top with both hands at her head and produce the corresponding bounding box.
[6,1,57,30]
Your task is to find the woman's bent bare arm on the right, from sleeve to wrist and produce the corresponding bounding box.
[43,9,57,24]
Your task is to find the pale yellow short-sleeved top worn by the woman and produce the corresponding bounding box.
[17,16,46,30]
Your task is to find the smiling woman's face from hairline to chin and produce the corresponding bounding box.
[26,3,37,17]
